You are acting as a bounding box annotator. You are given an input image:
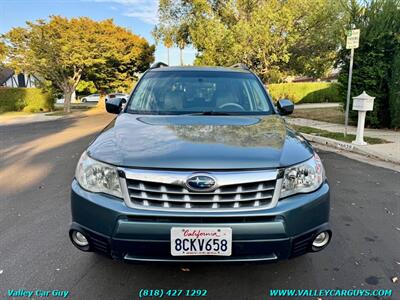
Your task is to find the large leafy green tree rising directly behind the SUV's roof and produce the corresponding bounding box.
[158,0,343,80]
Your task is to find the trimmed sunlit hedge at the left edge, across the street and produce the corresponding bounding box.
[0,88,54,113]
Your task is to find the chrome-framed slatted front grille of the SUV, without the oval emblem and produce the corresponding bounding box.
[119,168,282,213]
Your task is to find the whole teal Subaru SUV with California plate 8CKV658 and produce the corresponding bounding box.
[69,63,332,262]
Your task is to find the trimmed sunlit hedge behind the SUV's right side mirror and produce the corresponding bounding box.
[268,82,340,103]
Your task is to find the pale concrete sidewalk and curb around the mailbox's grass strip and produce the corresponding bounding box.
[286,118,400,164]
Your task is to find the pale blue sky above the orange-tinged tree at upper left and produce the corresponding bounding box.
[0,0,196,65]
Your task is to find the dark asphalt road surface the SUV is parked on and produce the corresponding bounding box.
[0,115,400,299]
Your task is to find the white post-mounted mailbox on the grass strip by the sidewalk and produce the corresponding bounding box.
[353,91,375,146]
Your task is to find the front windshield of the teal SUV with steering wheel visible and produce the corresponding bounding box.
[127,71,273,115]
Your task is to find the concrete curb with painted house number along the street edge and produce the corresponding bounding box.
[301,133,400,164]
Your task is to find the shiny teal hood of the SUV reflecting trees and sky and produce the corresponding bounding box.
[88,113,313,170]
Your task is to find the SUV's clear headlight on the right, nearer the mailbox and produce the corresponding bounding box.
[281,153,325,198]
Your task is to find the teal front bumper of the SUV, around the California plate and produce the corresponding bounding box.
[70,180,329,262]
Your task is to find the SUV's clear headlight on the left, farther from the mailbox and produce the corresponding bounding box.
[75,151,122,198]
